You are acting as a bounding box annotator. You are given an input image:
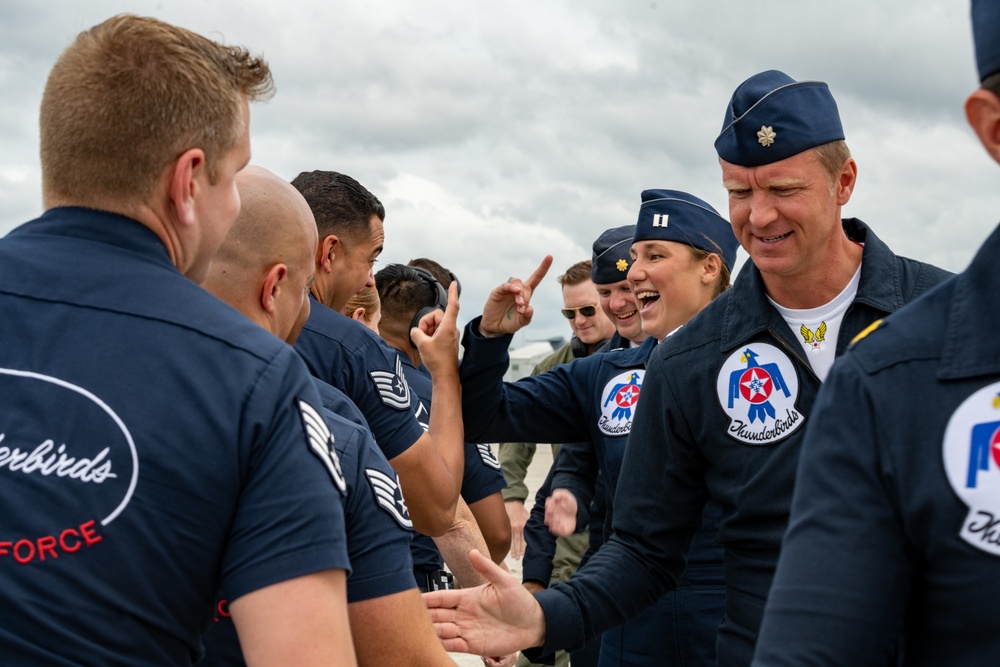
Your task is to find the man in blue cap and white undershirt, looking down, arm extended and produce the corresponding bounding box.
[426,70,947,665]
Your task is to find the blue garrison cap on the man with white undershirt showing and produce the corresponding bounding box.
[715,70,844,167]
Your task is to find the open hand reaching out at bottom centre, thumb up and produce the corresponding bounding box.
[423,550,545,656]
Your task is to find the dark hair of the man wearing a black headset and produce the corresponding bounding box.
[375,264,441,338]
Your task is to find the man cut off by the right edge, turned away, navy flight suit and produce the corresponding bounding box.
[754,0,1000,667]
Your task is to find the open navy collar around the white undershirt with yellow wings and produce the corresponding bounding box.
[720,218,905,352]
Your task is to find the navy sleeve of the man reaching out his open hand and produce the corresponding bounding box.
[526,355,708,659]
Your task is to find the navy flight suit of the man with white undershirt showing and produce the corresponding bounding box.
[537,218,948,666]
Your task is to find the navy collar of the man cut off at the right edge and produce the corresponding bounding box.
[938,226,1000,380]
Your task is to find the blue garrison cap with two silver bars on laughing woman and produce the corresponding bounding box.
[636,190,739,272]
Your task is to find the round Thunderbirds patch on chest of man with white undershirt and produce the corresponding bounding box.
[716,343,805,445]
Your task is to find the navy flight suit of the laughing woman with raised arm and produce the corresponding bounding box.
[460,330,724,665]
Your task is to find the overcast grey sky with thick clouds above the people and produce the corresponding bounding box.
[0,0,1000,344]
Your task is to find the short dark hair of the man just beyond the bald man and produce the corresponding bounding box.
[292,171,385,241]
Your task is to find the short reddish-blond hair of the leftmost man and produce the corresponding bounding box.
[40,14,274,202]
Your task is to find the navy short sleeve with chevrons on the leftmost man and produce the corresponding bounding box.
[222,347,349,601]
